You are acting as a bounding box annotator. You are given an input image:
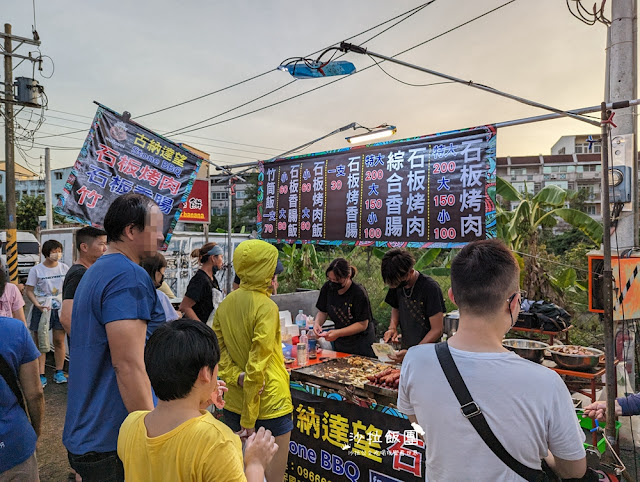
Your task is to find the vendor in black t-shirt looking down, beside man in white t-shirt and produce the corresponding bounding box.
[381,249,445,362]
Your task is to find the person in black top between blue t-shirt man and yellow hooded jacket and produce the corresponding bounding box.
[179,243,223,323]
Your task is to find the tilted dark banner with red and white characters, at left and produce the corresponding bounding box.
[55,105,202,251]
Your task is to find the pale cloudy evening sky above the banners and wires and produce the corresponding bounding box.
[0,0,632,172]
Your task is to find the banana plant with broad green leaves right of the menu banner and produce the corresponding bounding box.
[496,178,602,303]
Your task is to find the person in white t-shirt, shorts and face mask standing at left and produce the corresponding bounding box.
[25,239,69,387]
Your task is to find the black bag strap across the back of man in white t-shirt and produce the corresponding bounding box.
[435,342,545,482]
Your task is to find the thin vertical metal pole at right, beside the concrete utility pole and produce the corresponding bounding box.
[600,102,617,452]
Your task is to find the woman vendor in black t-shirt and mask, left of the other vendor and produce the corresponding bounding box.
[313,258,376,358]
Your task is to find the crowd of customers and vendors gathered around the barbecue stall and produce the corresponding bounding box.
[0,194,640,482]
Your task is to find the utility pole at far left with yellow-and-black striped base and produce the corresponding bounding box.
[4,23,18,284]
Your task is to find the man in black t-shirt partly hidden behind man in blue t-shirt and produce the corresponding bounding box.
[60,226,107,336]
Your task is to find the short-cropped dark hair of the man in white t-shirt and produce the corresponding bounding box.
[451,239,520,314]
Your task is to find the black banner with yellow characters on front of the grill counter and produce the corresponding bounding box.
[285,390,425,482]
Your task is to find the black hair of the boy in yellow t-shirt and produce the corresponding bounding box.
[144,318,220,401]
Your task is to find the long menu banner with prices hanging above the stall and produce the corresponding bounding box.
[257,126,496,248]
